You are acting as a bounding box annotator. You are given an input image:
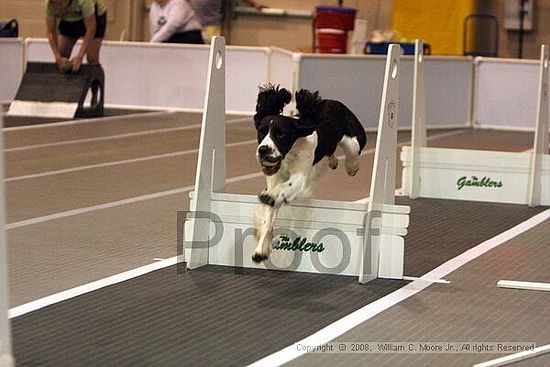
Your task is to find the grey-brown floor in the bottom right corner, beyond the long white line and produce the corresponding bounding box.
[285,214,550,367]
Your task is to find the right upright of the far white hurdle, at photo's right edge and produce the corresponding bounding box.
[528,45,549,206]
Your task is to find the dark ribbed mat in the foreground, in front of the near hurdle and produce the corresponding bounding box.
[12,266,405,367]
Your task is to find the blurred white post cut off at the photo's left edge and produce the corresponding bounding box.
[0,112,13,367]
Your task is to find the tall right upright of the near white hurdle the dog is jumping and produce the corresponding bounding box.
[359,44,402,283]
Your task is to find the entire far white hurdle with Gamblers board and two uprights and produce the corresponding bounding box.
[401,44,550,206]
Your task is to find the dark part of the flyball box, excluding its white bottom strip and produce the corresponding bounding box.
[8,62,105,118]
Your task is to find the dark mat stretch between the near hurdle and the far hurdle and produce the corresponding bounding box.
[396,197,547,277]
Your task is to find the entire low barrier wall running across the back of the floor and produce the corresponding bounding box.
[0,39,548,130]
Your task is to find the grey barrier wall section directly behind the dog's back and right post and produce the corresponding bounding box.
[298,54,473,129]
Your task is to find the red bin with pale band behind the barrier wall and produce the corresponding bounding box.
[313,6,357,54]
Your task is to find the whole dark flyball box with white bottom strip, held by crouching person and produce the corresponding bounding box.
[8,62,105,119]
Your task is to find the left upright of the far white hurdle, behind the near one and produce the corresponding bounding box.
[408,40,427,199]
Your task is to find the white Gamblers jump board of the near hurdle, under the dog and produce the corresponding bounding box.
[185,193,410,279]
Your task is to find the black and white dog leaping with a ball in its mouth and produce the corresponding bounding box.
[252,84,367,262]
